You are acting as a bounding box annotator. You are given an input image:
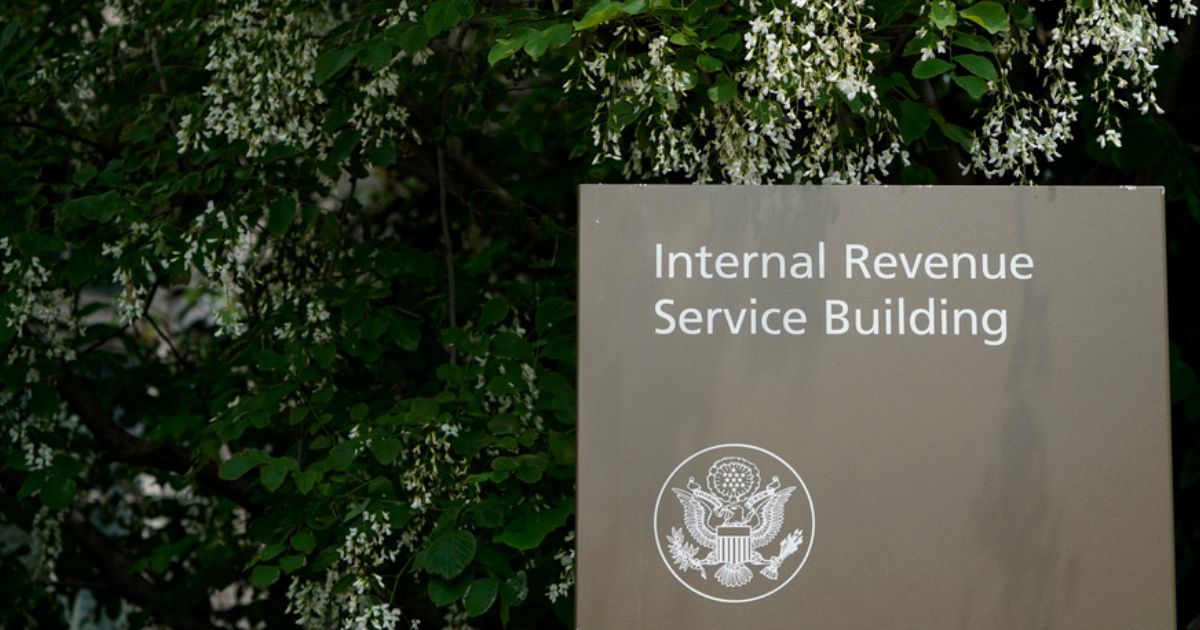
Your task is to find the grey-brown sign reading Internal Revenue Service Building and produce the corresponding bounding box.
[577,186,1175,630]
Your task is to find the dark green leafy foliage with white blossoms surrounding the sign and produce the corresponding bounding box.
[0,0,1200,628]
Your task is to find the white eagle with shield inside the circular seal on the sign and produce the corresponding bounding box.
[666,456,804,588]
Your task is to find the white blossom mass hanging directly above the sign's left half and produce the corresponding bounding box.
[568,0,907,184]
